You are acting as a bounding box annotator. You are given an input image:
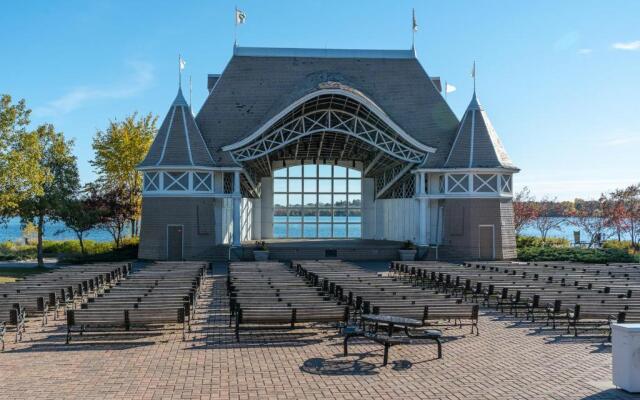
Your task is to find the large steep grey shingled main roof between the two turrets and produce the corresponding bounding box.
[196,48,458,167]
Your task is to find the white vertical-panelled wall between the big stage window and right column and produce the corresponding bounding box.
[375,198,418,243]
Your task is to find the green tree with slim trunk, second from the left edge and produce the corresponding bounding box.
[17,124,80,265]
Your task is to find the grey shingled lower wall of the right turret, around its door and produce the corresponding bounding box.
[442,199,515,260]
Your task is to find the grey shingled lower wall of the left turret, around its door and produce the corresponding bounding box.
[138,197,218,260]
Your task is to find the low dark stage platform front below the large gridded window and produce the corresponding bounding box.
[234,239,403,261]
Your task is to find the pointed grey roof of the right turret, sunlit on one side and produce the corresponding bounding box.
[445,91,518,169]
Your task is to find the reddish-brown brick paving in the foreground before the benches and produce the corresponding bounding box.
[0,270,634,399]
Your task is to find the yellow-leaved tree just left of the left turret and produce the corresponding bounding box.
[91,113,158,236]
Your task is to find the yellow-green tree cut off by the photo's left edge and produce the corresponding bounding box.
[0,94,45,220]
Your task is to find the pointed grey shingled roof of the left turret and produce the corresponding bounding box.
[139,89,215,168]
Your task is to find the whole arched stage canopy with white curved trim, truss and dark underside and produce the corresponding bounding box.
[222,88,435,197]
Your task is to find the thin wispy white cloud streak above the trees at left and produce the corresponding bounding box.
[34,61,154,117]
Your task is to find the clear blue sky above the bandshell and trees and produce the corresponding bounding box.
[0,0,640,199]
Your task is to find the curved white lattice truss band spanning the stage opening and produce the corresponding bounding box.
[231,109,427,164]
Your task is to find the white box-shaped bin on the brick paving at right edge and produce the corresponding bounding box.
[611,324,640,393]
